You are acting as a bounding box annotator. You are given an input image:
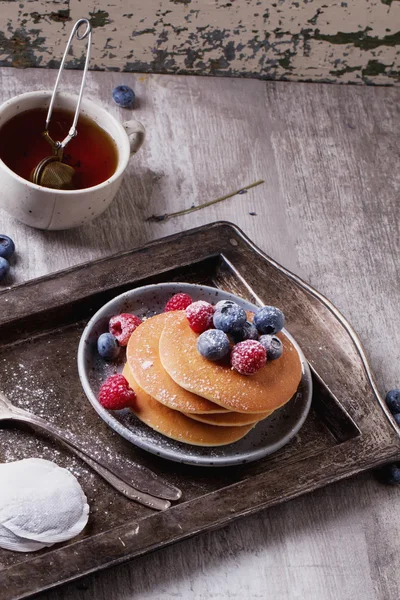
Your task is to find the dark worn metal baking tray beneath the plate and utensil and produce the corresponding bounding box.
[0,222,400,600]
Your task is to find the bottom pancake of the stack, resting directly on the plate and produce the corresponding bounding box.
[122,364,253,446]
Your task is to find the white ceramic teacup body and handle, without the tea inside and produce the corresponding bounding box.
[0,91,145,229]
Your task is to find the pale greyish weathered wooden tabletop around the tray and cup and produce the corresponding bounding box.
[0,69,400,600]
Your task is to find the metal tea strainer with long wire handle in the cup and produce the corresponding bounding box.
[31,19,92,190]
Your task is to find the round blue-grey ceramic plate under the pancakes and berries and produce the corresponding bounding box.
[78,283,312,467]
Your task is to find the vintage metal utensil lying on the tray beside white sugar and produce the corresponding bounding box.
[0,392,182,510]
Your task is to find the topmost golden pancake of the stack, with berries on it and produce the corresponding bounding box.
[159,311,302,413]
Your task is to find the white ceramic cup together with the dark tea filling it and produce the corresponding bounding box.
[0,91,145,229]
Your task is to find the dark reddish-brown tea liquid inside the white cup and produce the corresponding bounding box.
[0,108,118,190]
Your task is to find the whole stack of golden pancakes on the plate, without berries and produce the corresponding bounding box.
[123,311,302,446]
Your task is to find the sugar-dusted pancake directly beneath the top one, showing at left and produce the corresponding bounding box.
[126,313,227,414]
